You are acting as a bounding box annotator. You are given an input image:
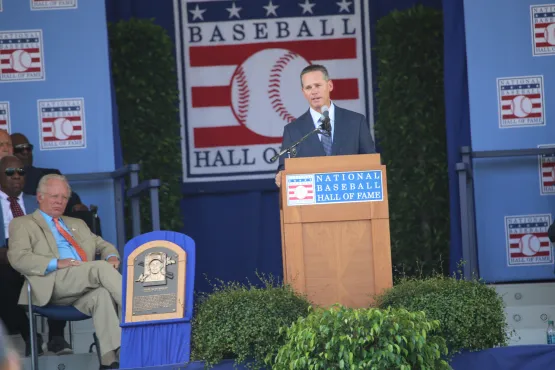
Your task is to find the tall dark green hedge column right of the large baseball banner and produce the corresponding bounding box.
[375,6,449,276]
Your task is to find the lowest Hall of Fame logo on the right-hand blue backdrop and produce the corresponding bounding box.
[505,214,553,266]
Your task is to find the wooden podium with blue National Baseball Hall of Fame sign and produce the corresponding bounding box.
[280,154,393,308]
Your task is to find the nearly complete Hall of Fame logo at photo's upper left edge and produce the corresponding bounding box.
[0,30,45,82]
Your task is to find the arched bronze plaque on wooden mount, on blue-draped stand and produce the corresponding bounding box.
[125,240,187,322]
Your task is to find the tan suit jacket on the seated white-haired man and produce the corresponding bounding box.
[8,209,120,306]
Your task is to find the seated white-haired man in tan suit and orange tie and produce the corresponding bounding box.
[8,174,122,369]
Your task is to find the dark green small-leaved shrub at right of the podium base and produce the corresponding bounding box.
[375,275,509,354]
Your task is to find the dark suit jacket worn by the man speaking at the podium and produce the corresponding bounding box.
[278,103,376,171]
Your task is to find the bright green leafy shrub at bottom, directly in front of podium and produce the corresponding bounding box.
[267,306,451,370]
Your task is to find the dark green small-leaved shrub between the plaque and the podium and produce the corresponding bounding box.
[192,277,310,369]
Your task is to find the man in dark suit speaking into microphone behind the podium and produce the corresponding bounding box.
[276,64,376,187]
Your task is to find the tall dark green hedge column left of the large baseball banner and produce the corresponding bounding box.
[108,19,182,235]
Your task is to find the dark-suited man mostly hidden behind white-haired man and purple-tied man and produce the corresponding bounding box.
[11,133,88,215]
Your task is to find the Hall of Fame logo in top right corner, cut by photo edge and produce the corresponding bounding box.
[530,4,555,56]
